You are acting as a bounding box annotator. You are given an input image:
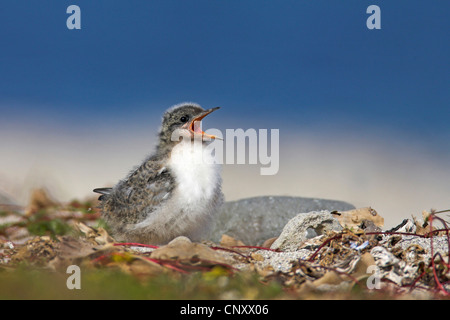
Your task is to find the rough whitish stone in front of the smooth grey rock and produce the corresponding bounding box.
[270,210,342,251]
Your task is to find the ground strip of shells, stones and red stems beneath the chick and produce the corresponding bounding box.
[0,199,450,299]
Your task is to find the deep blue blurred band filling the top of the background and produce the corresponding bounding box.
[0,0,450,142]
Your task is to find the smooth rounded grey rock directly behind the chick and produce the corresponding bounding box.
[210,196,355,245]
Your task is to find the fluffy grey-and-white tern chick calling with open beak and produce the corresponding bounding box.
[94,103,223,244]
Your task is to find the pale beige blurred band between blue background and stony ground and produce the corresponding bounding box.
[0,121,450,227]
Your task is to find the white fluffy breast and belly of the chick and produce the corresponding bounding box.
[130,142,221,243]
